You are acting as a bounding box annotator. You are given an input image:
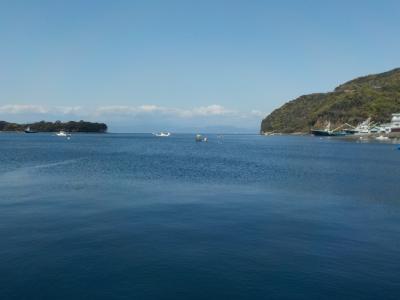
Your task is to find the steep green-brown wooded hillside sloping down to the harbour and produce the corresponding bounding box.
[261,68,400,133]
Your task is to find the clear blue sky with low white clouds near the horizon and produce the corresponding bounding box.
[0,0,400,133]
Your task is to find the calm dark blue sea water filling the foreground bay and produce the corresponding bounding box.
[0,134,400,299]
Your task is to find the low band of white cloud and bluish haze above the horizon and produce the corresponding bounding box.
[0,104,265,132]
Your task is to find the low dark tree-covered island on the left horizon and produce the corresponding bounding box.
[0,120,107,133]
